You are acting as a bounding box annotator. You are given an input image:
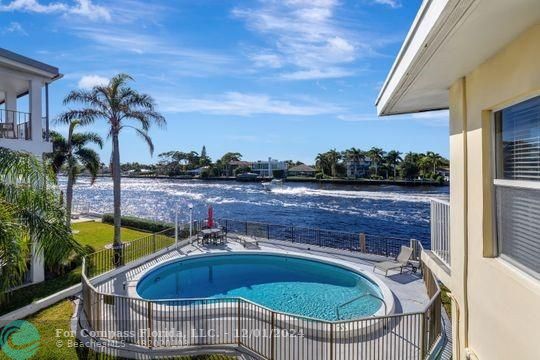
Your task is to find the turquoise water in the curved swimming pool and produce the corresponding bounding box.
[137,254,382,320]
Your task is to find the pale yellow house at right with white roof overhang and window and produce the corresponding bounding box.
[376,0,540,360]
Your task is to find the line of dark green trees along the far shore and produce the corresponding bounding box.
[117,146,449,181]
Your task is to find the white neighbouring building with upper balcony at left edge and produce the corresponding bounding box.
[0,48,62,283]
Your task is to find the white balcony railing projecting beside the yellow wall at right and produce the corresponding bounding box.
[431,199,450,267]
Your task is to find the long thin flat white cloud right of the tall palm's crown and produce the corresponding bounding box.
[156,92,342,116]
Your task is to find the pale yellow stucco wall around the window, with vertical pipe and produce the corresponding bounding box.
[449,24,540,360]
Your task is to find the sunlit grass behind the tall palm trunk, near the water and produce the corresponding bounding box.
[72,221,148,251]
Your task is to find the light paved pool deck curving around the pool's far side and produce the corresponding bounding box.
[95,237,429,314]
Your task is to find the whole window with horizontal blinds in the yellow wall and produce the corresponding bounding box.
[494,96,540,278]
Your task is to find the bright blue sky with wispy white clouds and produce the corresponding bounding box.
[0,0,448,163]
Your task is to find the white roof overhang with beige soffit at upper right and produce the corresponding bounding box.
[375,0,540,116]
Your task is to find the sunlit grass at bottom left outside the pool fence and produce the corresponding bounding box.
[0,300,234,360]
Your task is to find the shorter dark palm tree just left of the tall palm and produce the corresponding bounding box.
[47,120,103,226]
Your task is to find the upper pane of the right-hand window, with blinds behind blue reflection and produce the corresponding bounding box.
[495,97,540,181]
